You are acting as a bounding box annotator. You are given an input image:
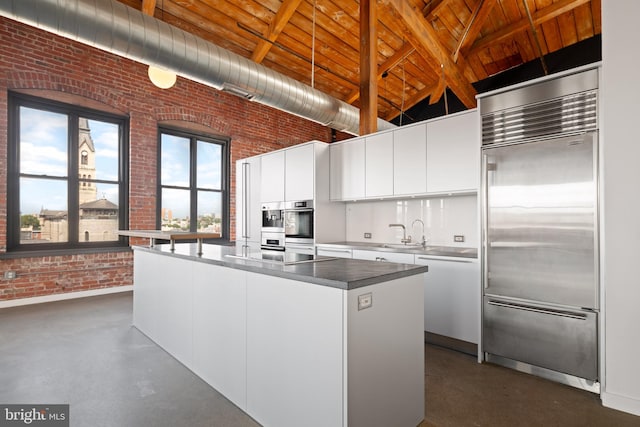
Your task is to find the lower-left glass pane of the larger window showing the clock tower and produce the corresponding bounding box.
[20,178,69,243]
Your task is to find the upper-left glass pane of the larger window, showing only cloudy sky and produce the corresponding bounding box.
[20,107,68,177]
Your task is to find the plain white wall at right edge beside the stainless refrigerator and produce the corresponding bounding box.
[600,0,640,415]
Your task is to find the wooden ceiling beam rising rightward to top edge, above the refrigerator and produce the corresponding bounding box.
[468,0,591,55]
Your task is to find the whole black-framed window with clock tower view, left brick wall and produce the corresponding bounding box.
[7,94,128,250]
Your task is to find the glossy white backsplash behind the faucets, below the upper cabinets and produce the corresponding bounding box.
[346,195,479,247]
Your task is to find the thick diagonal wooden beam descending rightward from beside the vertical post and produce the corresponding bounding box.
[380,0,476,108]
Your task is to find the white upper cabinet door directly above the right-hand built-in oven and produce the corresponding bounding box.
[284,144,315,201]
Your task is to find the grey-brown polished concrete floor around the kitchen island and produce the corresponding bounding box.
[0,293,640,427]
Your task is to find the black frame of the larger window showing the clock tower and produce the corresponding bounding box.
[7,92,129,253]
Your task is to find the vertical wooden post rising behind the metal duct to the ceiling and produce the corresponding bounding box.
[360,0,378,135]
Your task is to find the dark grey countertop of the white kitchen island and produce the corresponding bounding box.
[134,243,428,290]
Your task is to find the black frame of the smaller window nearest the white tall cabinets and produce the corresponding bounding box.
[156,126,231,243]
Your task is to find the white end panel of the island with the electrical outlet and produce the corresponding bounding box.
[346,274,425,427]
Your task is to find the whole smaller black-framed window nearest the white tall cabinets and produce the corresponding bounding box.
[157,129,229,239]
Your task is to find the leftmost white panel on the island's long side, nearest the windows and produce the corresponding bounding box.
[133,250,193,367]
